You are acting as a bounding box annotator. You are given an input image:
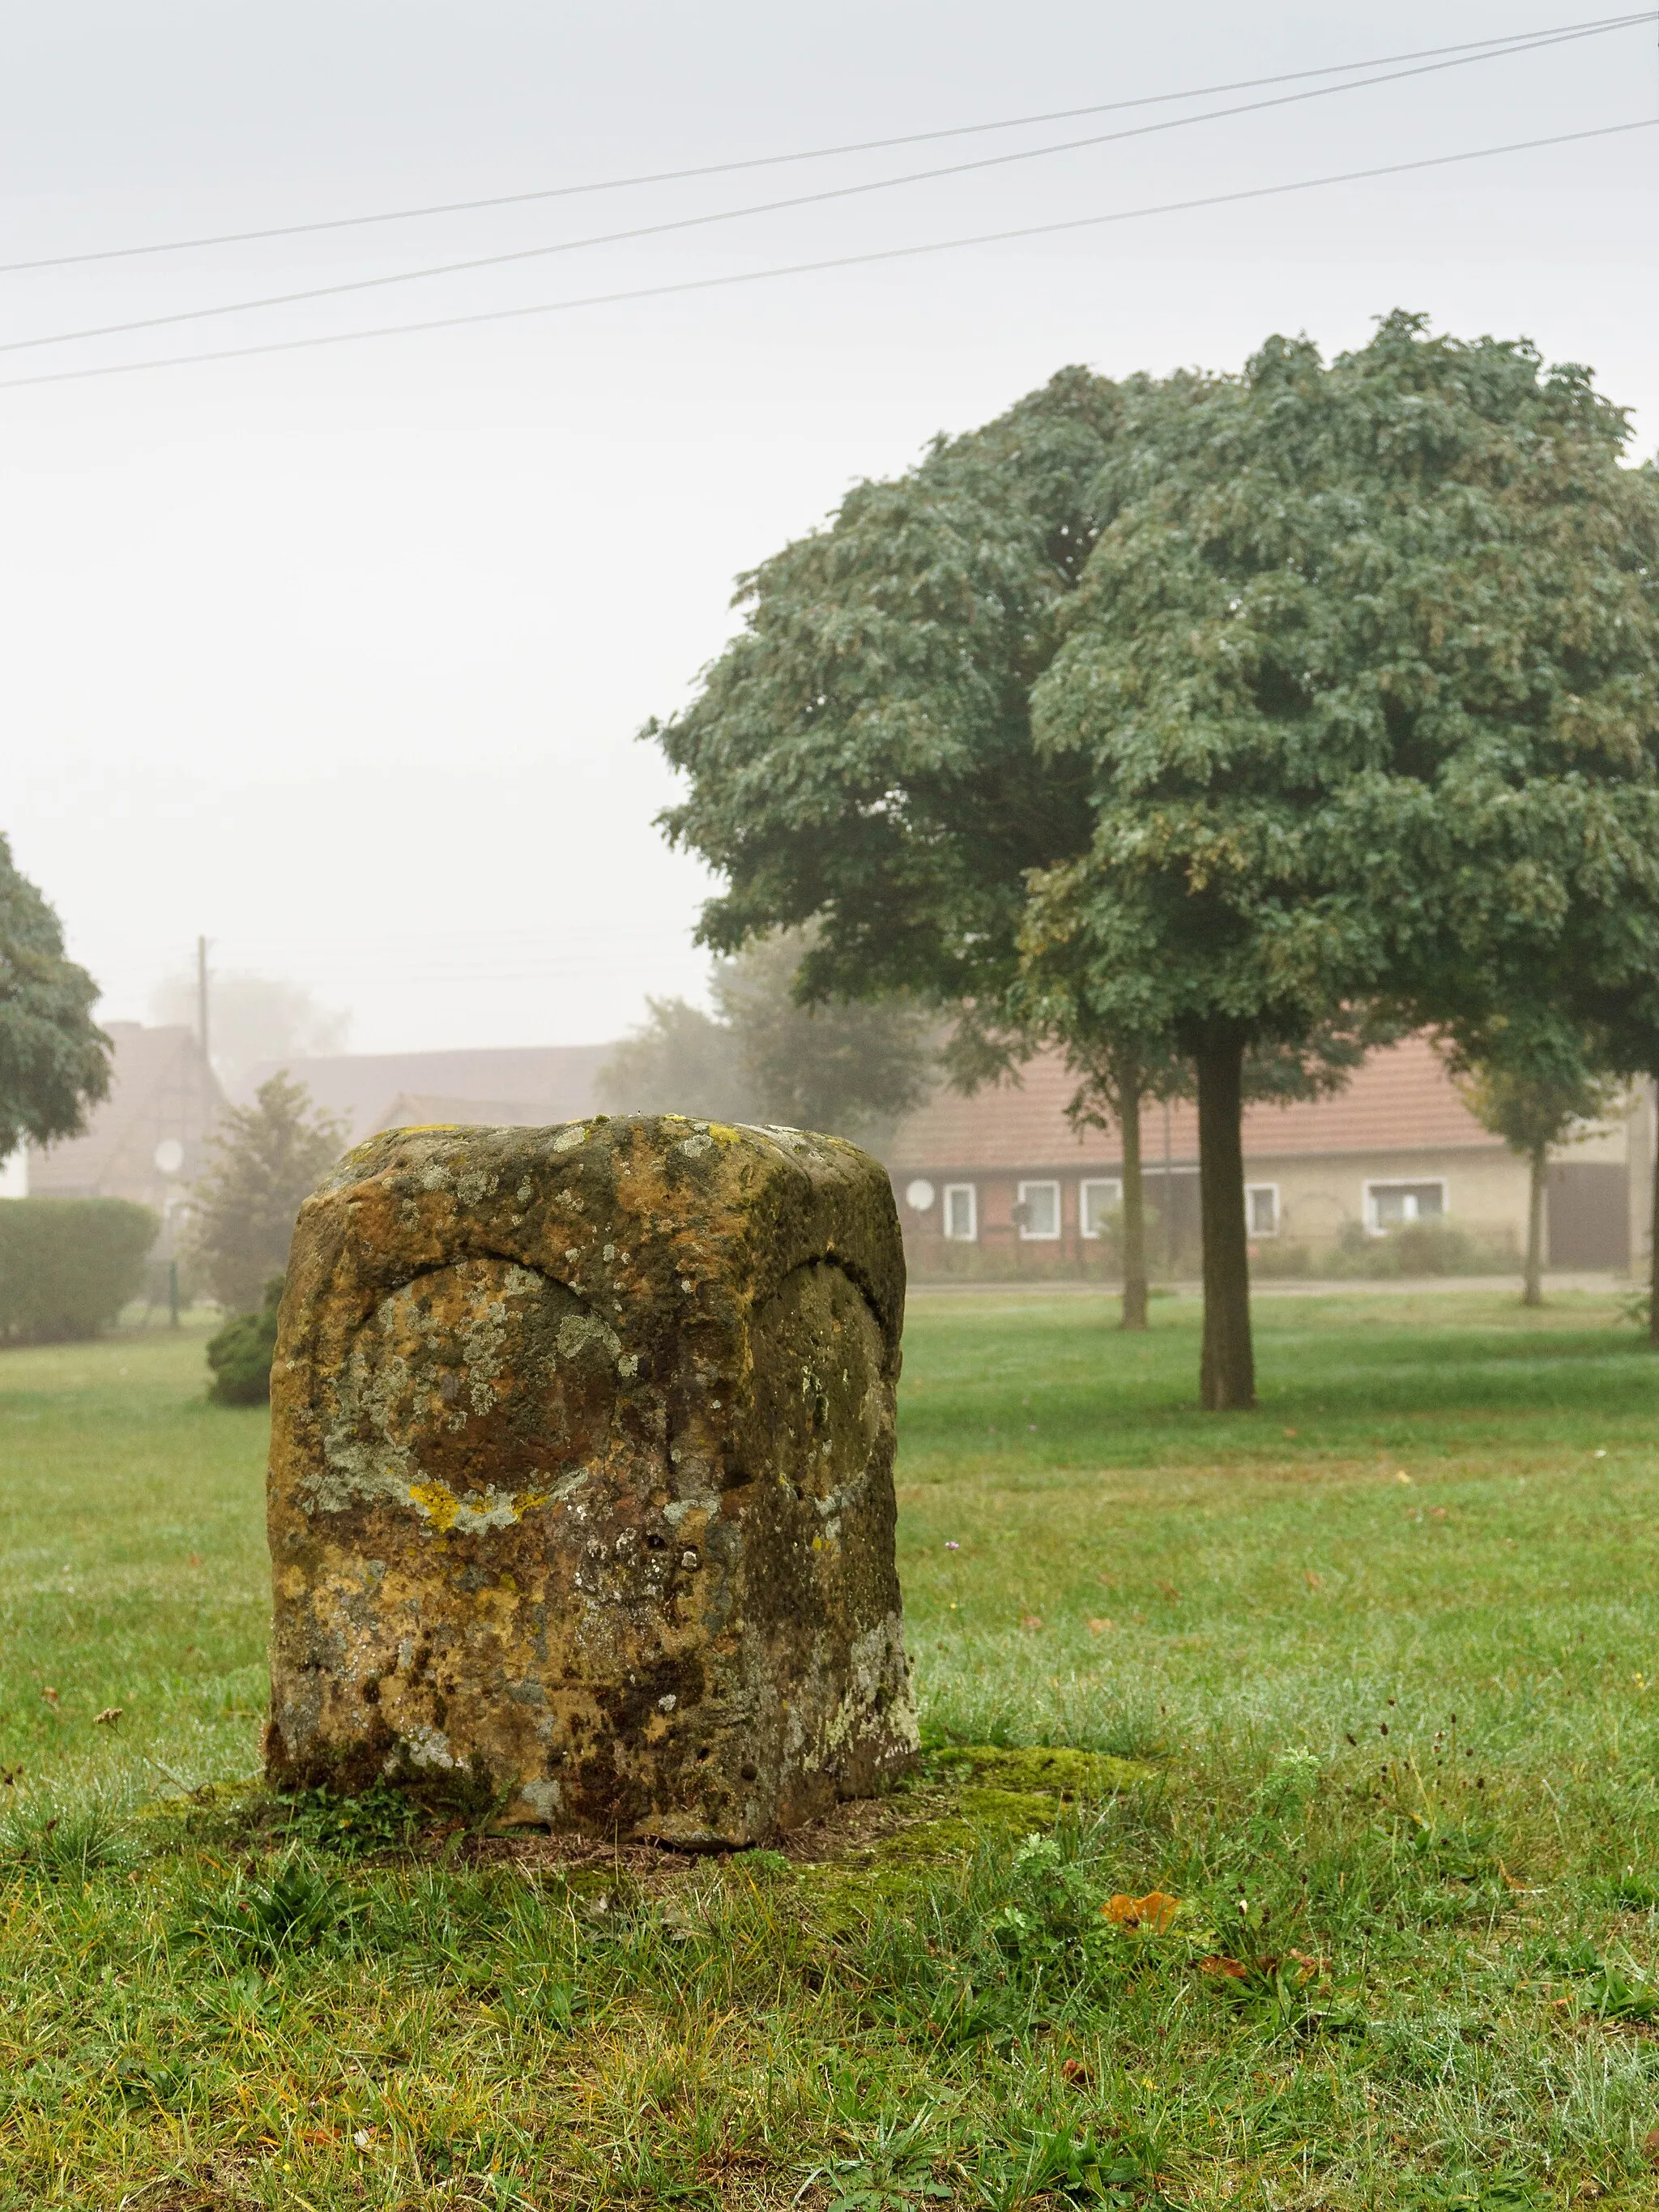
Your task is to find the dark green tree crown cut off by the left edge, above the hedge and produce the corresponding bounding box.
[0,836,111,1159]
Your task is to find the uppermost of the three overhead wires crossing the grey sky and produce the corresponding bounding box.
[0,9,1659,276]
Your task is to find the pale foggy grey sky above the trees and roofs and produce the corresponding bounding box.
[0,0,1659,1051]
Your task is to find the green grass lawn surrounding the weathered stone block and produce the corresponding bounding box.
[0,1292,1659,2212]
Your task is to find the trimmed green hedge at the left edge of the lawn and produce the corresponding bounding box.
[0,1199,161,1345]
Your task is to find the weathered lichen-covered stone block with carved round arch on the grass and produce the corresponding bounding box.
[267,1115,915,1847]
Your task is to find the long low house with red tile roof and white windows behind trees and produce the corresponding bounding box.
[889,1037,1655,1279]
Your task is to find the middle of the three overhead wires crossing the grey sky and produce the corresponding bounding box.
[0,15,1655,354]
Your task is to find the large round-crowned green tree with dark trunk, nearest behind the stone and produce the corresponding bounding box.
[1022,314,1659,1407]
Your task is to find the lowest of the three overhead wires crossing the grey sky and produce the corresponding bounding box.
[0,115,1659,391]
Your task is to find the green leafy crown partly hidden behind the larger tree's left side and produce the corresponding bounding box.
[650,369,1121,1004]
